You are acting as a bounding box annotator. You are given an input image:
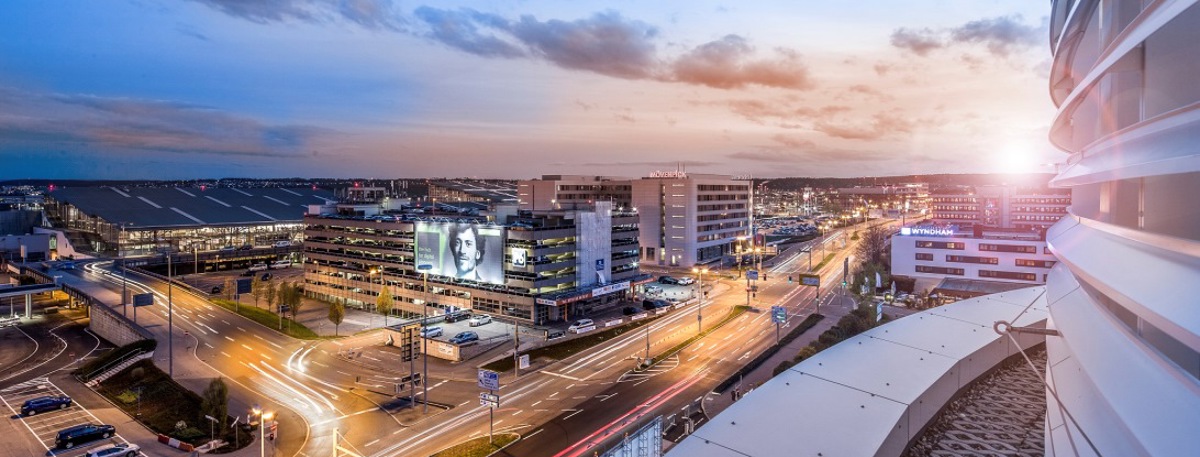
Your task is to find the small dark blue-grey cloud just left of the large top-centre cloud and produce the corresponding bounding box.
[414,6,526,58]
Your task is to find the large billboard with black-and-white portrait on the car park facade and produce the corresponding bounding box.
[416,221,504,285]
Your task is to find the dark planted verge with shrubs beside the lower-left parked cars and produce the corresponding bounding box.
[97,360,252,451]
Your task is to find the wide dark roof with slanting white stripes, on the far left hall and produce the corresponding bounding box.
[48,187,335,228]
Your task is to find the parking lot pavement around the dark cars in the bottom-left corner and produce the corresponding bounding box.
[0,378,138,456]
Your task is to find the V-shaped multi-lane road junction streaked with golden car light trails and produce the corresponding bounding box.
[0,219,883,457]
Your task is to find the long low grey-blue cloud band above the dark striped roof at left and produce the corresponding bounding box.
[0,88,330,157]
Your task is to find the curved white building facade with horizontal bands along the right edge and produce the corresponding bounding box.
[1045,0,1200,456]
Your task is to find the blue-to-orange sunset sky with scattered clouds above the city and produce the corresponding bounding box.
[0,0,1066,179]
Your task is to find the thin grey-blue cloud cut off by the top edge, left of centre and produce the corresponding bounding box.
[192,0,402,30]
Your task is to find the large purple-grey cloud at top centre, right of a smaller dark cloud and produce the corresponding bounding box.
[511,12,658,79]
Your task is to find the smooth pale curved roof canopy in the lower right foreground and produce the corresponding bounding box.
[668,287,1049,457]
